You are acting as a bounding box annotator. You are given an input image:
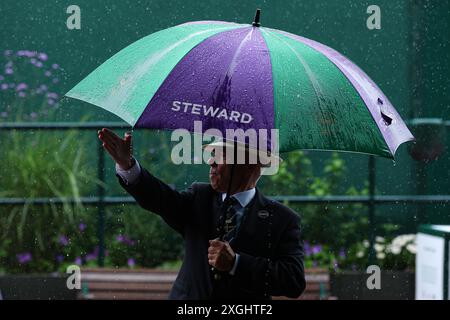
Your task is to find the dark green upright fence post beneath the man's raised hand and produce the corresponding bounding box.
[97,139,105,267]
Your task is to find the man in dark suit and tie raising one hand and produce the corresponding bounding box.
[98,129,305,299]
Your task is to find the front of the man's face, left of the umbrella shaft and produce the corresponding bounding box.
[208,150,231,192]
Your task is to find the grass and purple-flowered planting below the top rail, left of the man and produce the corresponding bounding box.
[0,131,186,273]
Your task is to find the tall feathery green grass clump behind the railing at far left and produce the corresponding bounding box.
[0,131,96,272]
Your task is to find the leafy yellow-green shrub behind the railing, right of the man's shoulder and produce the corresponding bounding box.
[264,151,368,251]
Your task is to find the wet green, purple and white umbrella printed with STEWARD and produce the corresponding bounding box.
[66,10,413,158]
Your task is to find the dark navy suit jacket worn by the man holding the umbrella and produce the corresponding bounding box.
[118,168,305,299]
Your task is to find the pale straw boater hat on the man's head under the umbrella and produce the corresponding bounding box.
[203,140,283,167]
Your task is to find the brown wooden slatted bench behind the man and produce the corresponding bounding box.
[78,269,330,300]
